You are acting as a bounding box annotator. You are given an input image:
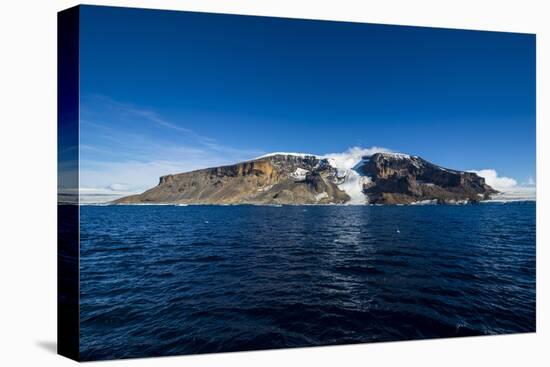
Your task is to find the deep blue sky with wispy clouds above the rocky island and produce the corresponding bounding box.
[80,7,536,194]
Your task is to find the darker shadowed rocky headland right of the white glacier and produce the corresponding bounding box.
[358,153,497,204]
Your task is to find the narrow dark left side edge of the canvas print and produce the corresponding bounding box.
[57,7,79,360]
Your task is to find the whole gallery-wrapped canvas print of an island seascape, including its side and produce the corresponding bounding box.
[58,6,536,361]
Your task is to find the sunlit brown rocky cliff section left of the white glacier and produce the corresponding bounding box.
[114,154,349,204]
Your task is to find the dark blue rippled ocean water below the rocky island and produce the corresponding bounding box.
[80,202,536,360]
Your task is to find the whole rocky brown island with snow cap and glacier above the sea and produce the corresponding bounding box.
[113,153,498,204]
